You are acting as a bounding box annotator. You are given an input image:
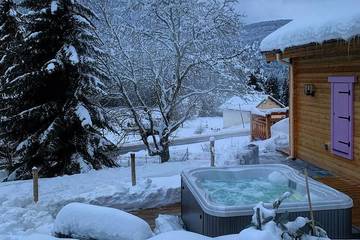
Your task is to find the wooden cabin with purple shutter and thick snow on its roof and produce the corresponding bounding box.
[261,14,360,181]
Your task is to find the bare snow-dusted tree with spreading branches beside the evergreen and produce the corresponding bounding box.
[97,0,242,162]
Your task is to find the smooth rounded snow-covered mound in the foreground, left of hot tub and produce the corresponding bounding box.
[54,203,153,240]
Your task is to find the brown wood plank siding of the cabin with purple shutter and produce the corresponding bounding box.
[290,40,360,181]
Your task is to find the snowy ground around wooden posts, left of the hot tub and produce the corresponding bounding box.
[0,161,208,239]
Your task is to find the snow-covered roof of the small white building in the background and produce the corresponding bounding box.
[220,94,269,112]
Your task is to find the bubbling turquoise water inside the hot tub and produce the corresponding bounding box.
[196,171,317,206]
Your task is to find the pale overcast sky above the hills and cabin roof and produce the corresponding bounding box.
[238,0,360,23]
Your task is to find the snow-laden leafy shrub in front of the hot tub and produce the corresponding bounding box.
[239,192,329,240]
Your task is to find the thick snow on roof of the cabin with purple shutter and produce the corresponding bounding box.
[260,0,360,52]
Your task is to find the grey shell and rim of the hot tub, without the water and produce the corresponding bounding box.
[181,164,353,239]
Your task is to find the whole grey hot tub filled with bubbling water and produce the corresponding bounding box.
[181,164,353,238]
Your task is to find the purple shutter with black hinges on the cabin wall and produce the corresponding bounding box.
[329,77,355,159]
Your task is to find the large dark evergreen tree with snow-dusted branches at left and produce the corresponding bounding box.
[0,0,116,180]
